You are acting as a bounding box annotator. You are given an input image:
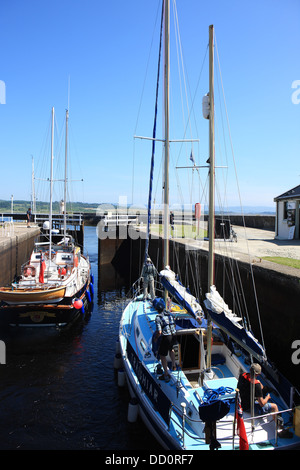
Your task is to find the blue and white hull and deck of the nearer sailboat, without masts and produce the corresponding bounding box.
[119,299,300,451]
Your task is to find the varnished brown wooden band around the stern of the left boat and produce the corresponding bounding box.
[0,287,66,305]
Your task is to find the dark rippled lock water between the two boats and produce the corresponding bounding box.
[0,227,159,450]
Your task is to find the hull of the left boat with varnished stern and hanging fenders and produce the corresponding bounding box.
[0,241,94,327]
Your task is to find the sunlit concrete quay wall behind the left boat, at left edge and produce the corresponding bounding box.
[0,222,40,286]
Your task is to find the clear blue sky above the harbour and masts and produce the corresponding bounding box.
[0,0,300,206]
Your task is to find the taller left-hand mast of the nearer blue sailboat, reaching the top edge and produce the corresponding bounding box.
[164,0,170,267]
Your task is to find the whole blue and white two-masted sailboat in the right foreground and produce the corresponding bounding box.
[119,0,300,451]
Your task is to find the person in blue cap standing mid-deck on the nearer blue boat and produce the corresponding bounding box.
[153,299,177,382]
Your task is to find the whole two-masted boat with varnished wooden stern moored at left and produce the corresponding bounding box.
[0,108,93,328]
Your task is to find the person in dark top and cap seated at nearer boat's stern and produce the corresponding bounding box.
[237,363,283,425]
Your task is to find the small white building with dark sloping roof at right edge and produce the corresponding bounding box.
[274,185,300,240]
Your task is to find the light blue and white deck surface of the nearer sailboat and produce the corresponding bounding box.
[120,297,299,450]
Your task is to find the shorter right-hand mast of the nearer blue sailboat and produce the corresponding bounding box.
[208,25,215,290]
